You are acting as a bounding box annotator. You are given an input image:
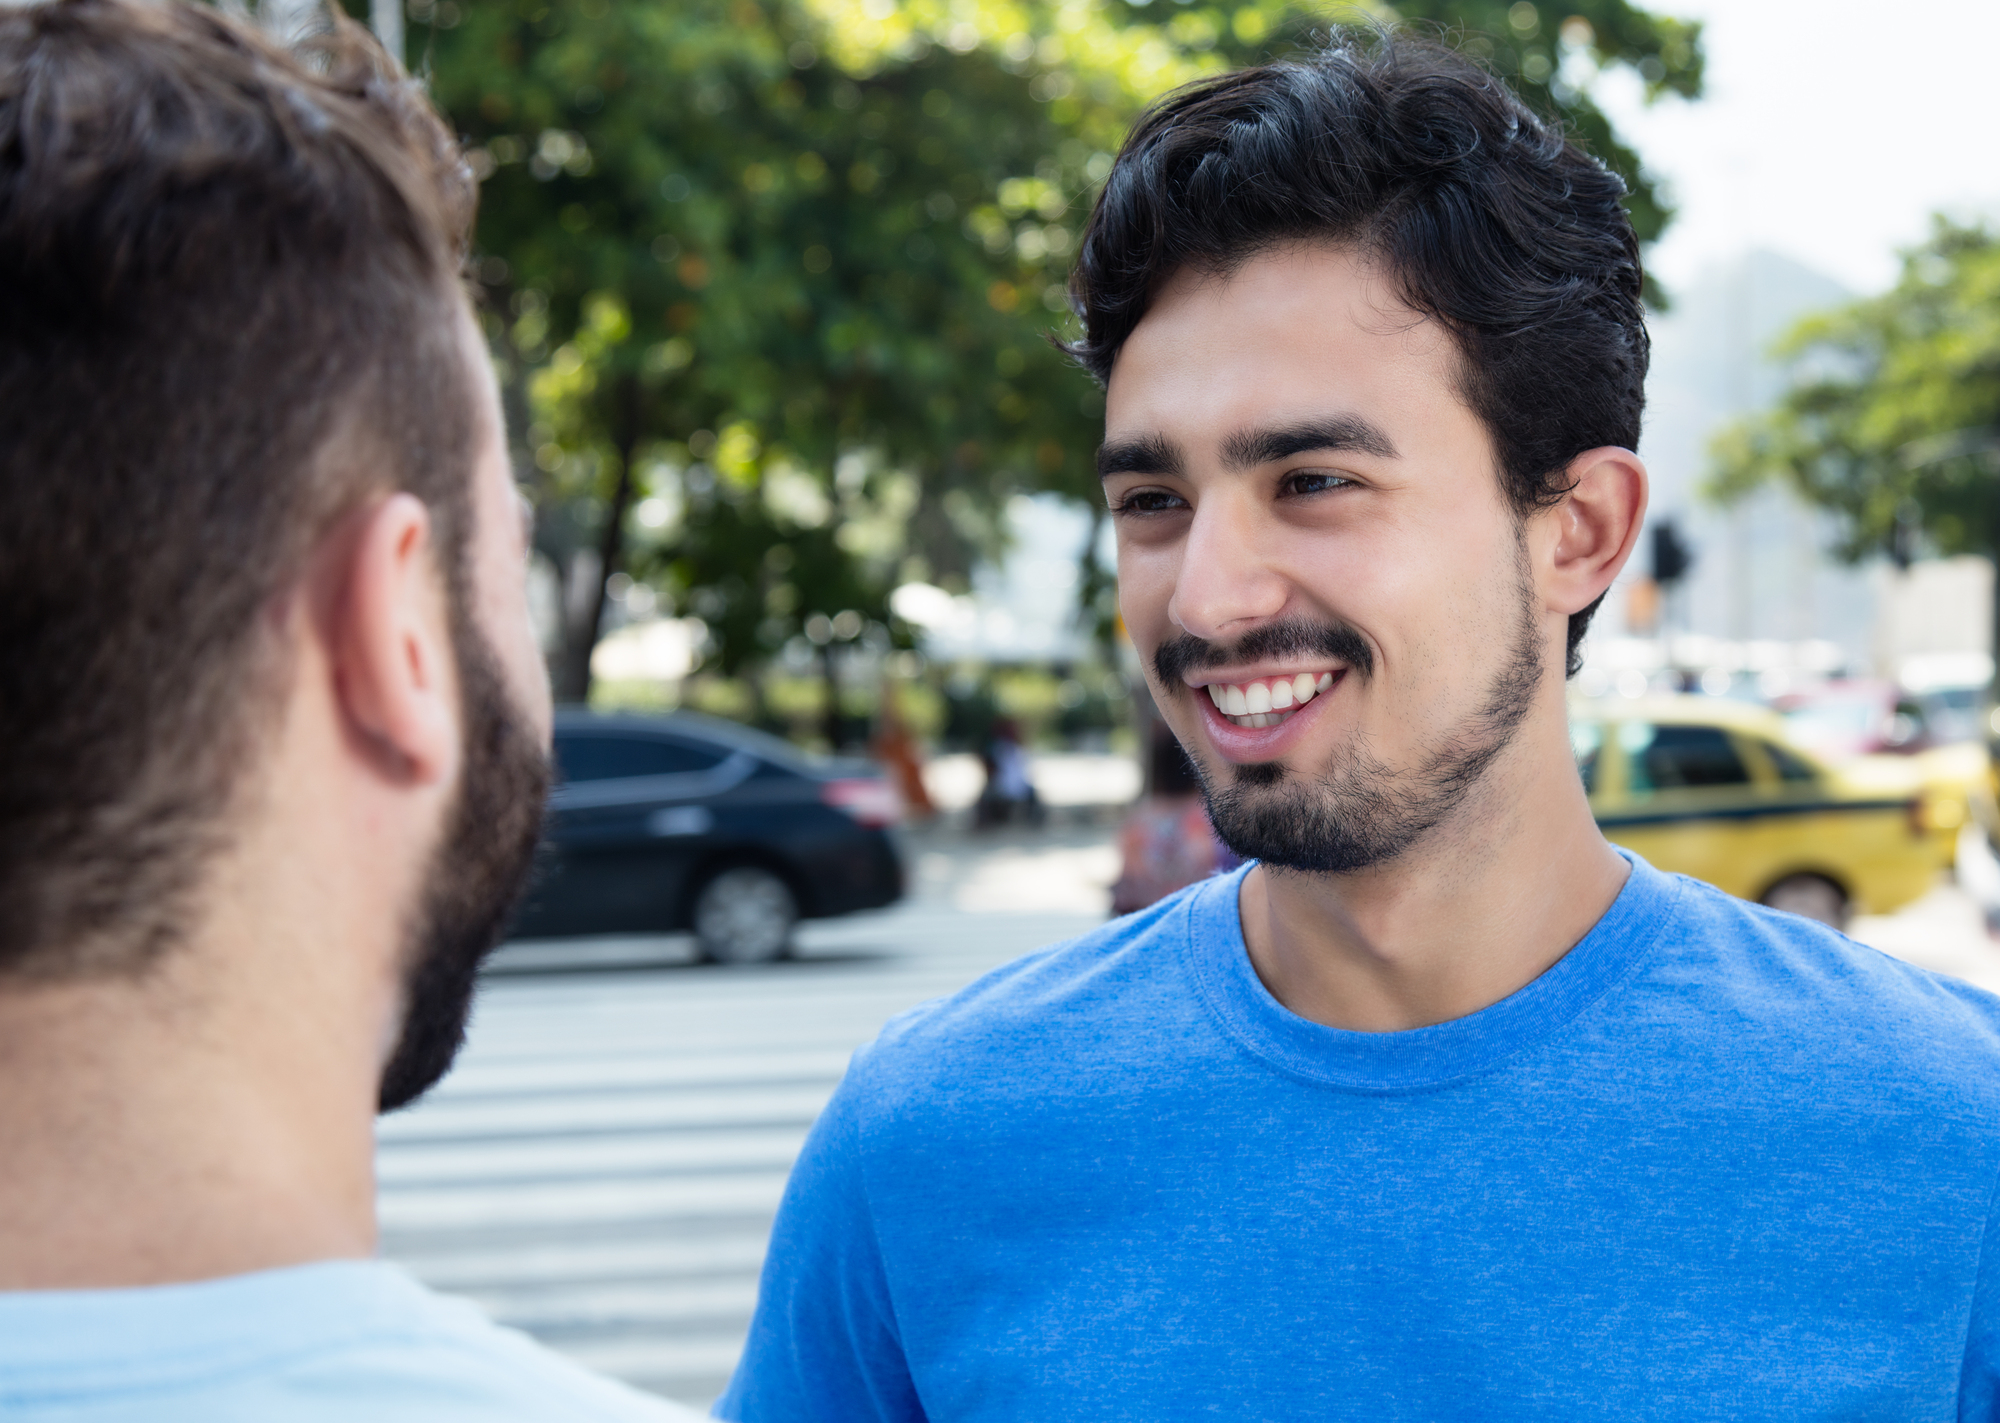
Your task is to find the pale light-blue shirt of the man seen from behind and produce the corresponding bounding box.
[0,1261,700,1423]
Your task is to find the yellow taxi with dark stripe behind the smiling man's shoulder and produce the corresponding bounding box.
[1570,698,1952,927]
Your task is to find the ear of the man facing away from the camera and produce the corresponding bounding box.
[326,494,460,783]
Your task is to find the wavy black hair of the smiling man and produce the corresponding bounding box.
[1068,34,1648,676]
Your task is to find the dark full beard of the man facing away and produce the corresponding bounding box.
[380,616,550,1111]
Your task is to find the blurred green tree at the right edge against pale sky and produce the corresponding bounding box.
[1710,218,2000,671]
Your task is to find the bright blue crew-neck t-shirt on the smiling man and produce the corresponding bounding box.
[716,861,2000,1423]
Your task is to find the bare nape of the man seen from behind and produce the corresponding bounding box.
[0,927,374,1289]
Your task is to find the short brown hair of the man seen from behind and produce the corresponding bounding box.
[0,0,476,977]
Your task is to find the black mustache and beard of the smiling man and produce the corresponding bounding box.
[1154,570,1546,873]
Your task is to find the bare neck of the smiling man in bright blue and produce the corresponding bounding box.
[1238,727,1628,1033]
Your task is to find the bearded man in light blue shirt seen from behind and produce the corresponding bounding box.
[0,0,694,1423]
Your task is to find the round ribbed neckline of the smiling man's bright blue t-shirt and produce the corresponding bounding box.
[1186,849,1682,1091]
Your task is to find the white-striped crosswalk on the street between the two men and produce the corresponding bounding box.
[364,831,1108,1405]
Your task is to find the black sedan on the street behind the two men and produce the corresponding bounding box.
[514,712,902,963]
